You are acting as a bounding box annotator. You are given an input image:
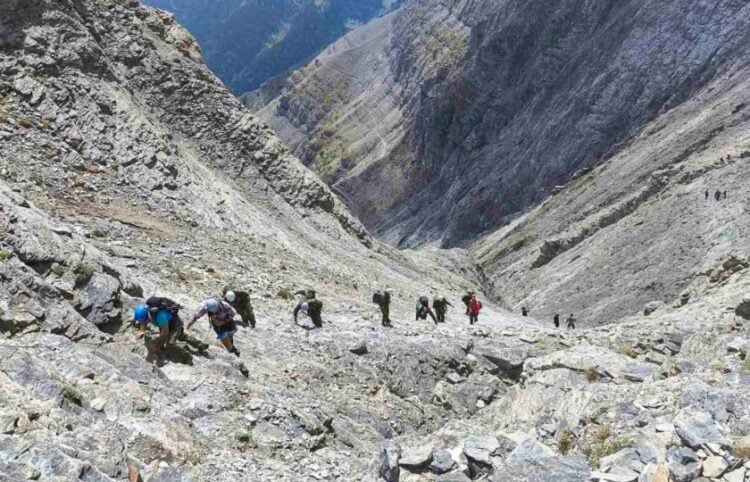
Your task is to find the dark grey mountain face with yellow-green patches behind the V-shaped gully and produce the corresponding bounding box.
[258,0,750,246]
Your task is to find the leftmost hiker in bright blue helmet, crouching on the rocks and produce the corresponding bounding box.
[133,296,208,357]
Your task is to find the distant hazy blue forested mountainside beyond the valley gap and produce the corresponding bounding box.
[143,0,399,94]
